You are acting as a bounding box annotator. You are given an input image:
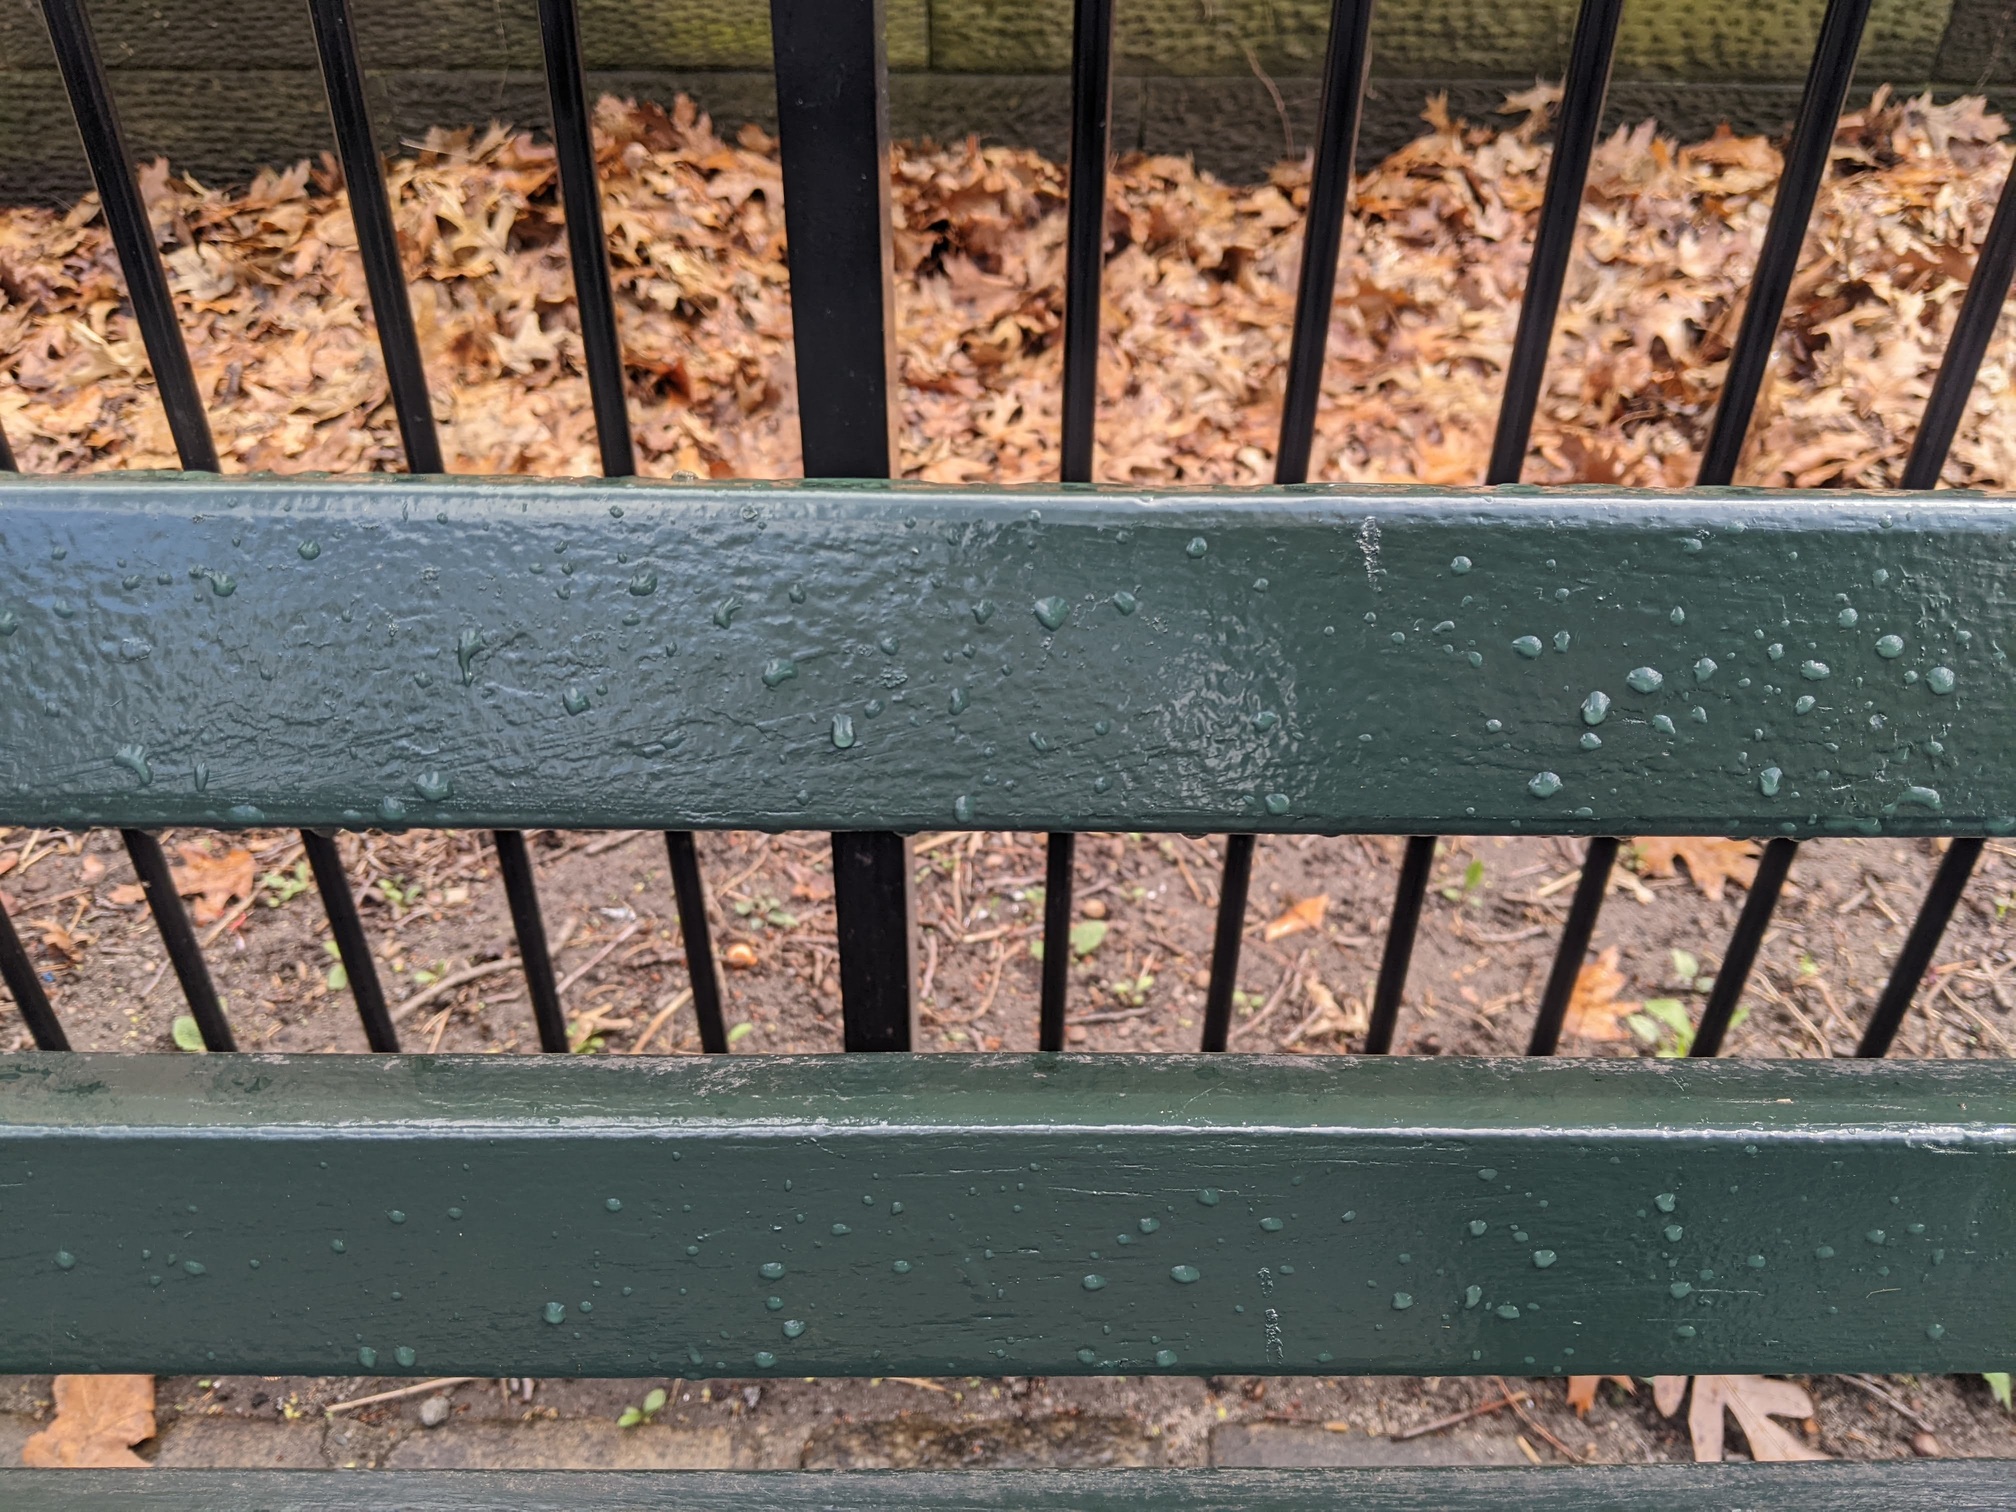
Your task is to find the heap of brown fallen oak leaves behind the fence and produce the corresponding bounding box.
[0,89,2016,486]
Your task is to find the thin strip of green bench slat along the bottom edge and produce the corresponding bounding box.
[0,1467,2010,1512]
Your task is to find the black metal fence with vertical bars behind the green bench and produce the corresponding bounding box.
[0,0,2016,1056]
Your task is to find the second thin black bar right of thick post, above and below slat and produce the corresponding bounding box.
[1204,0,1373,1050]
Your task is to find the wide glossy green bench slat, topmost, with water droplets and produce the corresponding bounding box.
[0,474,2016,835]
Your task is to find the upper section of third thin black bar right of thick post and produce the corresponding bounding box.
[1484,0,1625,484]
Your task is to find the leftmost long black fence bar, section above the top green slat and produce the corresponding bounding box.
[42,0,218,473]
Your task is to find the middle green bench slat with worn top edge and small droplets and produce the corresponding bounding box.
[0,1054,2016,1377]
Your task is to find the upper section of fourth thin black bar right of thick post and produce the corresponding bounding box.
[1699,0,1871,486]
